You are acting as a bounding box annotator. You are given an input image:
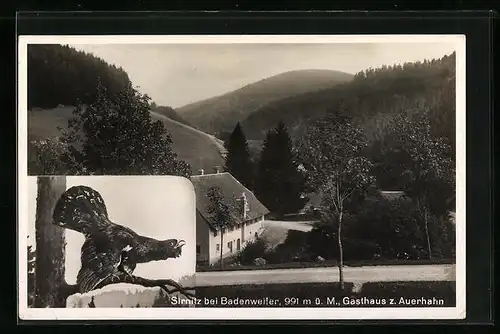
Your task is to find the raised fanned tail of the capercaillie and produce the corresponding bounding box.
[52,186,111,235]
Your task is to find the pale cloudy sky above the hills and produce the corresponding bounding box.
[71,41,456,108]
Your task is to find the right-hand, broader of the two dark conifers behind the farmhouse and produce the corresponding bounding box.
[255,121,307,216]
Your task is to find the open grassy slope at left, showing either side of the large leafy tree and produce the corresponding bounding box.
[28,107,224,172]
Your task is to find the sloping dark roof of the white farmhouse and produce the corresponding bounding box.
[191,172,269,230]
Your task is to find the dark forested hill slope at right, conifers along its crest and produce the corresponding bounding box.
[242,53,455,140]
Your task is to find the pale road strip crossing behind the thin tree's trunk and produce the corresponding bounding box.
[196,264,455,286]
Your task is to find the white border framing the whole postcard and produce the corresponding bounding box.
[17,35,466,320]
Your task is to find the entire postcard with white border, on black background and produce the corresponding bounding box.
[18,35,465,319]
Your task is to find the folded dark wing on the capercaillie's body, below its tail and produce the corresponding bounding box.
[76,237,121,293]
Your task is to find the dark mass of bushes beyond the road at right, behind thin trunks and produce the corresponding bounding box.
[306,198,455,261]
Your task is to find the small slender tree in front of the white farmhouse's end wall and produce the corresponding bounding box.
[207,187,232,268]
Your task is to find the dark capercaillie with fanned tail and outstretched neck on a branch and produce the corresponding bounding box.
[52,186,186,293]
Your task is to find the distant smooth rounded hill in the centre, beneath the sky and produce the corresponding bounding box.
[176,70,353,134]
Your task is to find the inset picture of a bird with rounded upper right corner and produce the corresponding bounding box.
[24,176,196,314]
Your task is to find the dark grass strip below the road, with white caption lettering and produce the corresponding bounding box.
[196,282,456,307]
